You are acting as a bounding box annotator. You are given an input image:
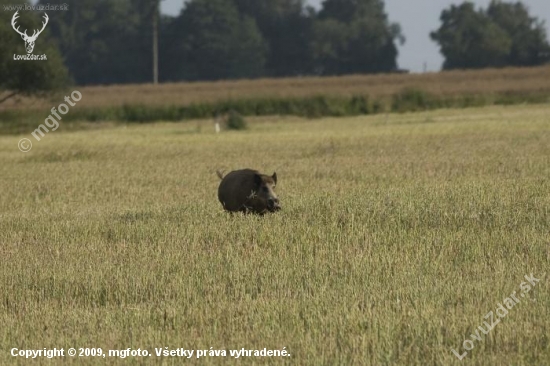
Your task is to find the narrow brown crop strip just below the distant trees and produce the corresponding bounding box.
[0,66,550,110]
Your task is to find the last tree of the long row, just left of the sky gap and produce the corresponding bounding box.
[312,0,404,75]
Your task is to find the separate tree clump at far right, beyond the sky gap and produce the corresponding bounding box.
[430,1,549,69]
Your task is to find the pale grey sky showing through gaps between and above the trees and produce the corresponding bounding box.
[161,0,550,72]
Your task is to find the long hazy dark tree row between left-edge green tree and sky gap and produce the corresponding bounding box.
[40,0,402,84]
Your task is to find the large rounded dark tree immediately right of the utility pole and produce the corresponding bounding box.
[164,0,267,80]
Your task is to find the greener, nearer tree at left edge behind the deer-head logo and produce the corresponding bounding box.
[0,0,70,104]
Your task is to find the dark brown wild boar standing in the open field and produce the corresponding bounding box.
[217,169,281,215]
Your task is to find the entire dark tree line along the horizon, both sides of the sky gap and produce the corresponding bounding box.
[0,0,550,102]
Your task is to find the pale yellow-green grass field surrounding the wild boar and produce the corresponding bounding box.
[0,101,550,365]
